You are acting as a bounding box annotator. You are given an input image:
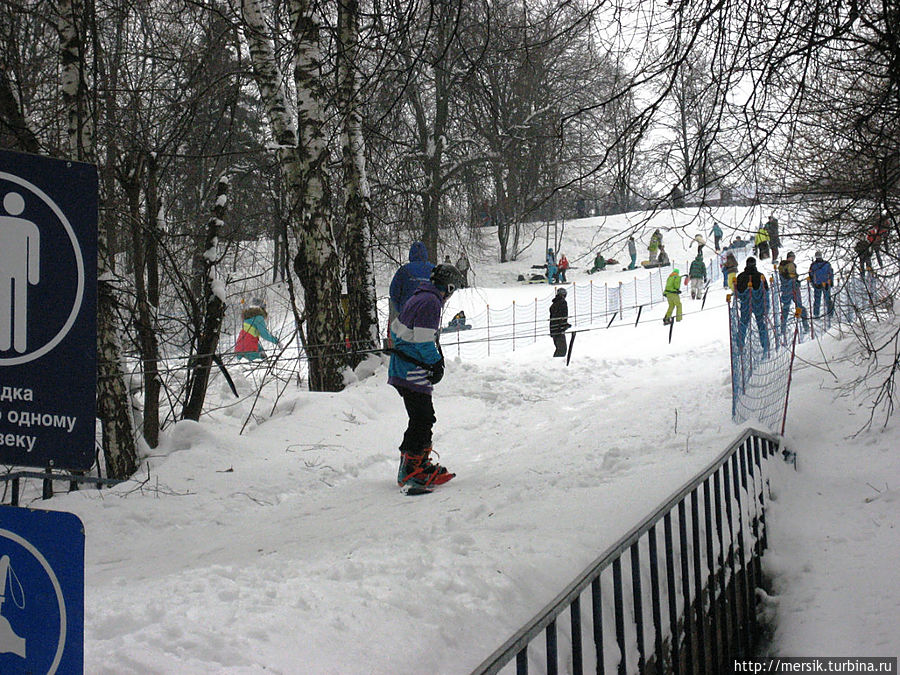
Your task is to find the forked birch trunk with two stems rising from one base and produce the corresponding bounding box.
[240,0,346,391]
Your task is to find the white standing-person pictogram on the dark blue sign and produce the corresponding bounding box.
[0,187,41,354]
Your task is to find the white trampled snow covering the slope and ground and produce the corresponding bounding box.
[12,209,900,675]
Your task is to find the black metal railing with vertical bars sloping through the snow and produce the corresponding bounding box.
[473,429,792,675]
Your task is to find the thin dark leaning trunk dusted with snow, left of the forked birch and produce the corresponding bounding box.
[182,176,228,422]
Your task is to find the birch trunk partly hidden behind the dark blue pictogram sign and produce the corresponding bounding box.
[56,0,138,479]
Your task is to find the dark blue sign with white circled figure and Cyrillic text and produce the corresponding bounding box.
[0,151,97,471]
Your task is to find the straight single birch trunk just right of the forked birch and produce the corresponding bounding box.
[338,0,378,363]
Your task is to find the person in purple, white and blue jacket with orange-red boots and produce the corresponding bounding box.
[388,263,462,490]
